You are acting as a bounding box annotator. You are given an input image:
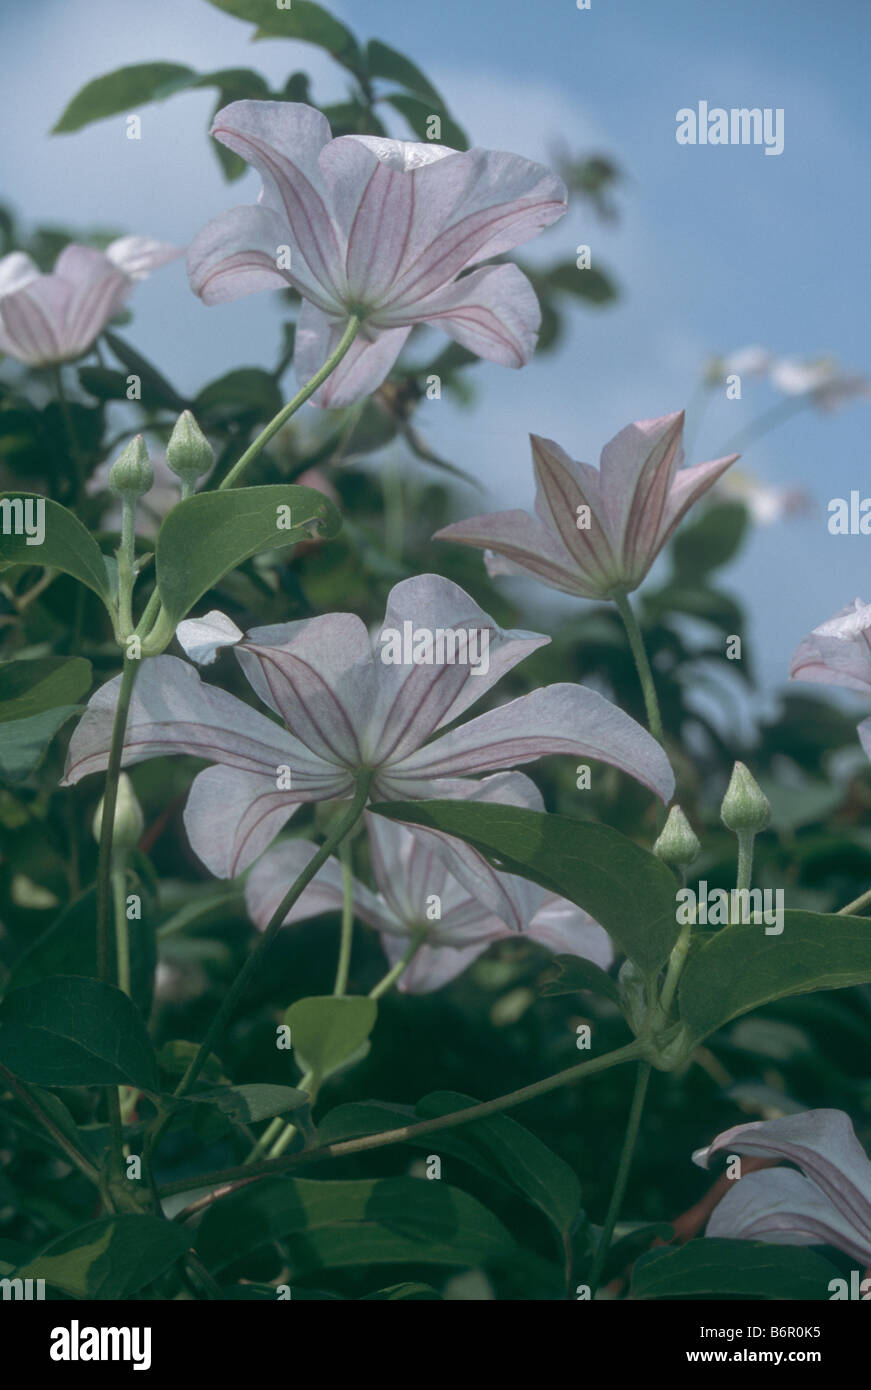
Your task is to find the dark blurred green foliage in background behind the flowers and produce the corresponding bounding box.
[0,0,871,1298]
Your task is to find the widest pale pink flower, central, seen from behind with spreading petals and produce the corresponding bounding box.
[65,574,674,877]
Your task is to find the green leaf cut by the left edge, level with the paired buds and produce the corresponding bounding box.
[0,492,110,603]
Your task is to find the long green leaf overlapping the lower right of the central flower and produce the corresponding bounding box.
[370,801,678,973]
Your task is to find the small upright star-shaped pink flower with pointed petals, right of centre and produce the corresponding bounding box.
[436,410,738,599]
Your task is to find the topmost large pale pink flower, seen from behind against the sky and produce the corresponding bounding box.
[188,101,567,406]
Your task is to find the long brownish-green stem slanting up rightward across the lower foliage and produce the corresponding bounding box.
[160,1040,642,1197]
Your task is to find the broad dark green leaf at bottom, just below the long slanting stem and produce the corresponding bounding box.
[196,1177,514,1275]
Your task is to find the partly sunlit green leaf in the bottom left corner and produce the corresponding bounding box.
[15,1216,190,1300]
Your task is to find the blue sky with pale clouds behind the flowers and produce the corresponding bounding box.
[0,0,871,688]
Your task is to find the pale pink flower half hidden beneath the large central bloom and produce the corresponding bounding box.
[244,773,614,994]
